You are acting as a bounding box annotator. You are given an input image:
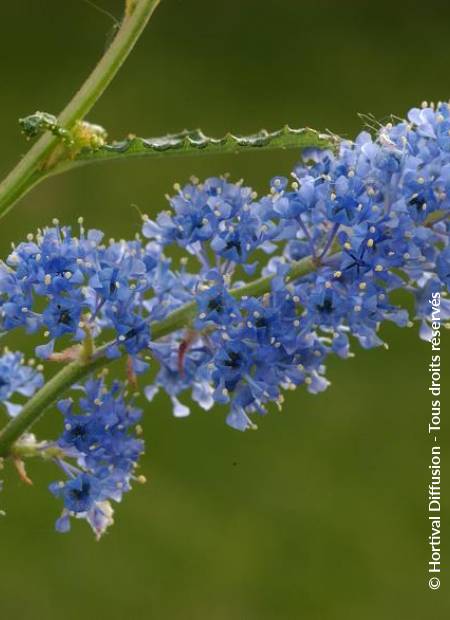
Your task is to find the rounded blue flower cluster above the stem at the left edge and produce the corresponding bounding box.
[0,219,174,372]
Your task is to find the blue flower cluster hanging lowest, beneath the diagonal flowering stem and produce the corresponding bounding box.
[47,377,144,538]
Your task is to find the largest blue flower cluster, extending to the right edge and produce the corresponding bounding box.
[143,103,450,430]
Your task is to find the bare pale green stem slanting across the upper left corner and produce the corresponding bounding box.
[0,0,160,217]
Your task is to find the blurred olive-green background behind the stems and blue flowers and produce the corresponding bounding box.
[0,0,450,620]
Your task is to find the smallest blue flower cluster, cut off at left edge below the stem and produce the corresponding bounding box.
[0,349,44,417]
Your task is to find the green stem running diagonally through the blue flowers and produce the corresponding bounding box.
[0,249,324,457]
